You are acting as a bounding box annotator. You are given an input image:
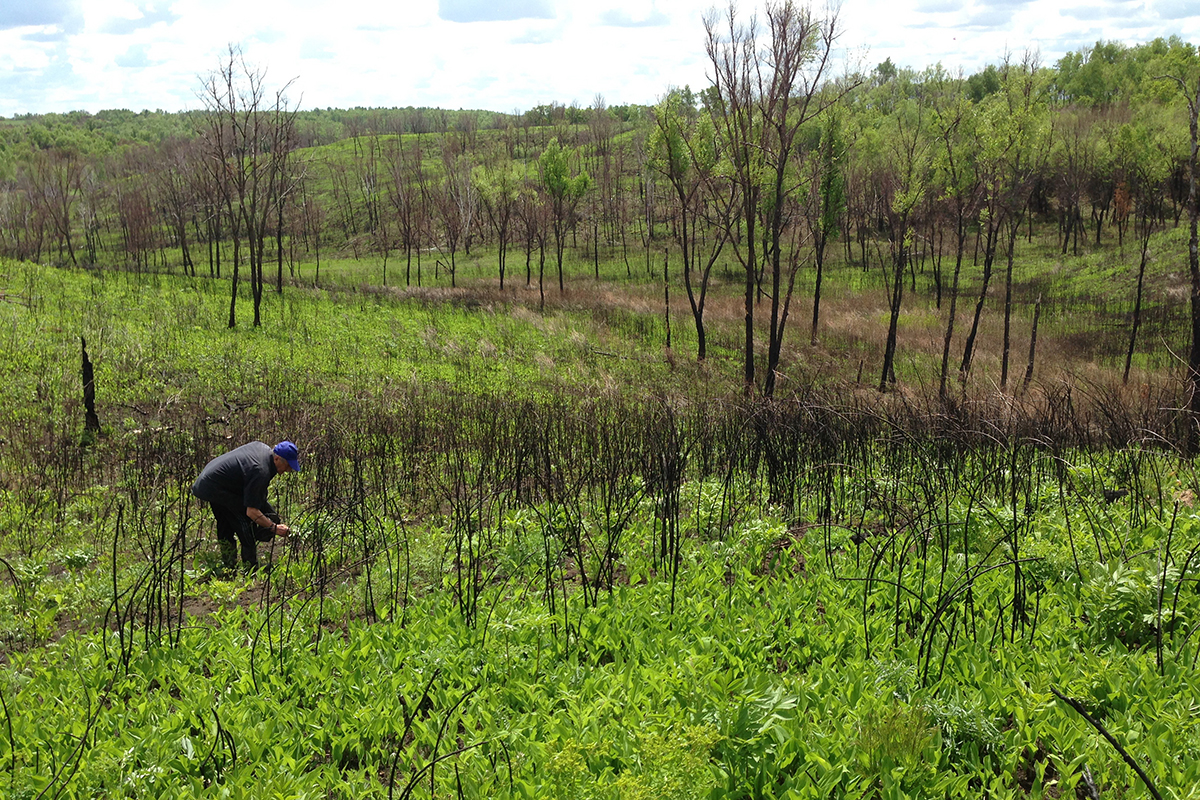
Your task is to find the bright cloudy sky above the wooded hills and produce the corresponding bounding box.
[0,0,1200,116]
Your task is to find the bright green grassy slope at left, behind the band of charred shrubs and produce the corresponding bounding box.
[0,257,700,427]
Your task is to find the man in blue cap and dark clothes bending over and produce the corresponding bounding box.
[192,441,300,571]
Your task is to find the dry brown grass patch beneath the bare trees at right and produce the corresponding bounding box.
[355,260,1183,441]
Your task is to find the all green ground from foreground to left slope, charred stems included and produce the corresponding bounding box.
[0,253,1200,800]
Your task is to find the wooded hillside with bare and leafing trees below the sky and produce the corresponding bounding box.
[7,7,1200,414]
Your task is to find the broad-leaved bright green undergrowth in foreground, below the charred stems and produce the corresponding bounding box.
[7,485,1200,799]
